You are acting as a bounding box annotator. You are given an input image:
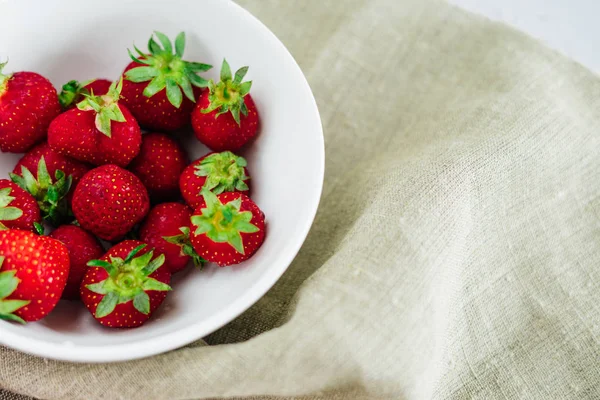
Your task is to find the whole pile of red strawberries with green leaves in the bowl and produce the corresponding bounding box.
[0,32,265,328]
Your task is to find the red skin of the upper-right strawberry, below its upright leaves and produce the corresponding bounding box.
[192,91,259,152]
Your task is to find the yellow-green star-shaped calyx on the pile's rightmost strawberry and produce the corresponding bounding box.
[191,190,259,254]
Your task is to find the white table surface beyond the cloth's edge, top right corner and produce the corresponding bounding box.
[449,0,600,73]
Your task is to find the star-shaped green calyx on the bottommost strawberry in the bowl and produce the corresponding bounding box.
[86,244,171,318]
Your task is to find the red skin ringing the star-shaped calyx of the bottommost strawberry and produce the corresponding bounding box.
[80,240,171,328]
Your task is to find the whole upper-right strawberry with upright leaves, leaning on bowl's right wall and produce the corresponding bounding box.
[192,60,259,151]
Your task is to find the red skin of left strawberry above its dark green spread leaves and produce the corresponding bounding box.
[13,142,91,198]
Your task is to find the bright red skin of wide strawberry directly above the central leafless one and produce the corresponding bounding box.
[48,104,142,167]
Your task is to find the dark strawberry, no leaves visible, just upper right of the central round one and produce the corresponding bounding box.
[129,133,188,200]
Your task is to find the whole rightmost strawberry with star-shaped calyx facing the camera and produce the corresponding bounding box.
[190,190,265,267]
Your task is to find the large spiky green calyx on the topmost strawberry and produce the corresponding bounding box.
[125,32,212,108]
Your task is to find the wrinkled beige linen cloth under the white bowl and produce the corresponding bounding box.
[0,0,600,400]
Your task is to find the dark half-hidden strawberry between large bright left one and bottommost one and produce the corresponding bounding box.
[49,225,104,300]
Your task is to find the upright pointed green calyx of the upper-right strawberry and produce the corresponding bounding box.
[202,60,252,125]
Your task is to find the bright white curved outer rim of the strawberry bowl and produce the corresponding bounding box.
[0,1,325,363]
